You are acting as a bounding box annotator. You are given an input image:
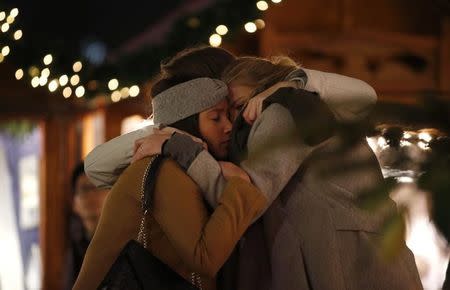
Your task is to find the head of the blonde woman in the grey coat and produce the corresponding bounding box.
[222,56,298,117]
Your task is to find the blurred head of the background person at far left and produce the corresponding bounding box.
[71,162,108,235]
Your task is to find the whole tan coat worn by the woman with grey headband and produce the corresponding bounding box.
[73,158,266,290]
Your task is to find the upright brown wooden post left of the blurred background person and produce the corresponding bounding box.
[40,115,76,289]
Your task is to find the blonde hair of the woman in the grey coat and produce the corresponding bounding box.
[222,56,299,98]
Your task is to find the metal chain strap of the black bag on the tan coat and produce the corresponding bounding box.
[137,155,203,290]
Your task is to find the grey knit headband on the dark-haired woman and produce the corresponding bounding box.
[152,78,228,125]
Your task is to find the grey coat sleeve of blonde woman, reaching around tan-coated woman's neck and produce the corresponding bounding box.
[169,104,312,218]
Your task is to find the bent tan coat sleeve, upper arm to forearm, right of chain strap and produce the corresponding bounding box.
[154,161,267,277]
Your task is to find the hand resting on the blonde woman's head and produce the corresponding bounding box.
[242,81,297,125]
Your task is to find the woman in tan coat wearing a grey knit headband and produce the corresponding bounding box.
[73,78,266,290]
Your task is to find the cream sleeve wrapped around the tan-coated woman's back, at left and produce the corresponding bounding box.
[84,126,153,188]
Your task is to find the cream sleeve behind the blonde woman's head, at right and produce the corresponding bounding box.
[302,68,377,122]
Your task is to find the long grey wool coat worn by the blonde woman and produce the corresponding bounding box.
[187,104,422,290]
